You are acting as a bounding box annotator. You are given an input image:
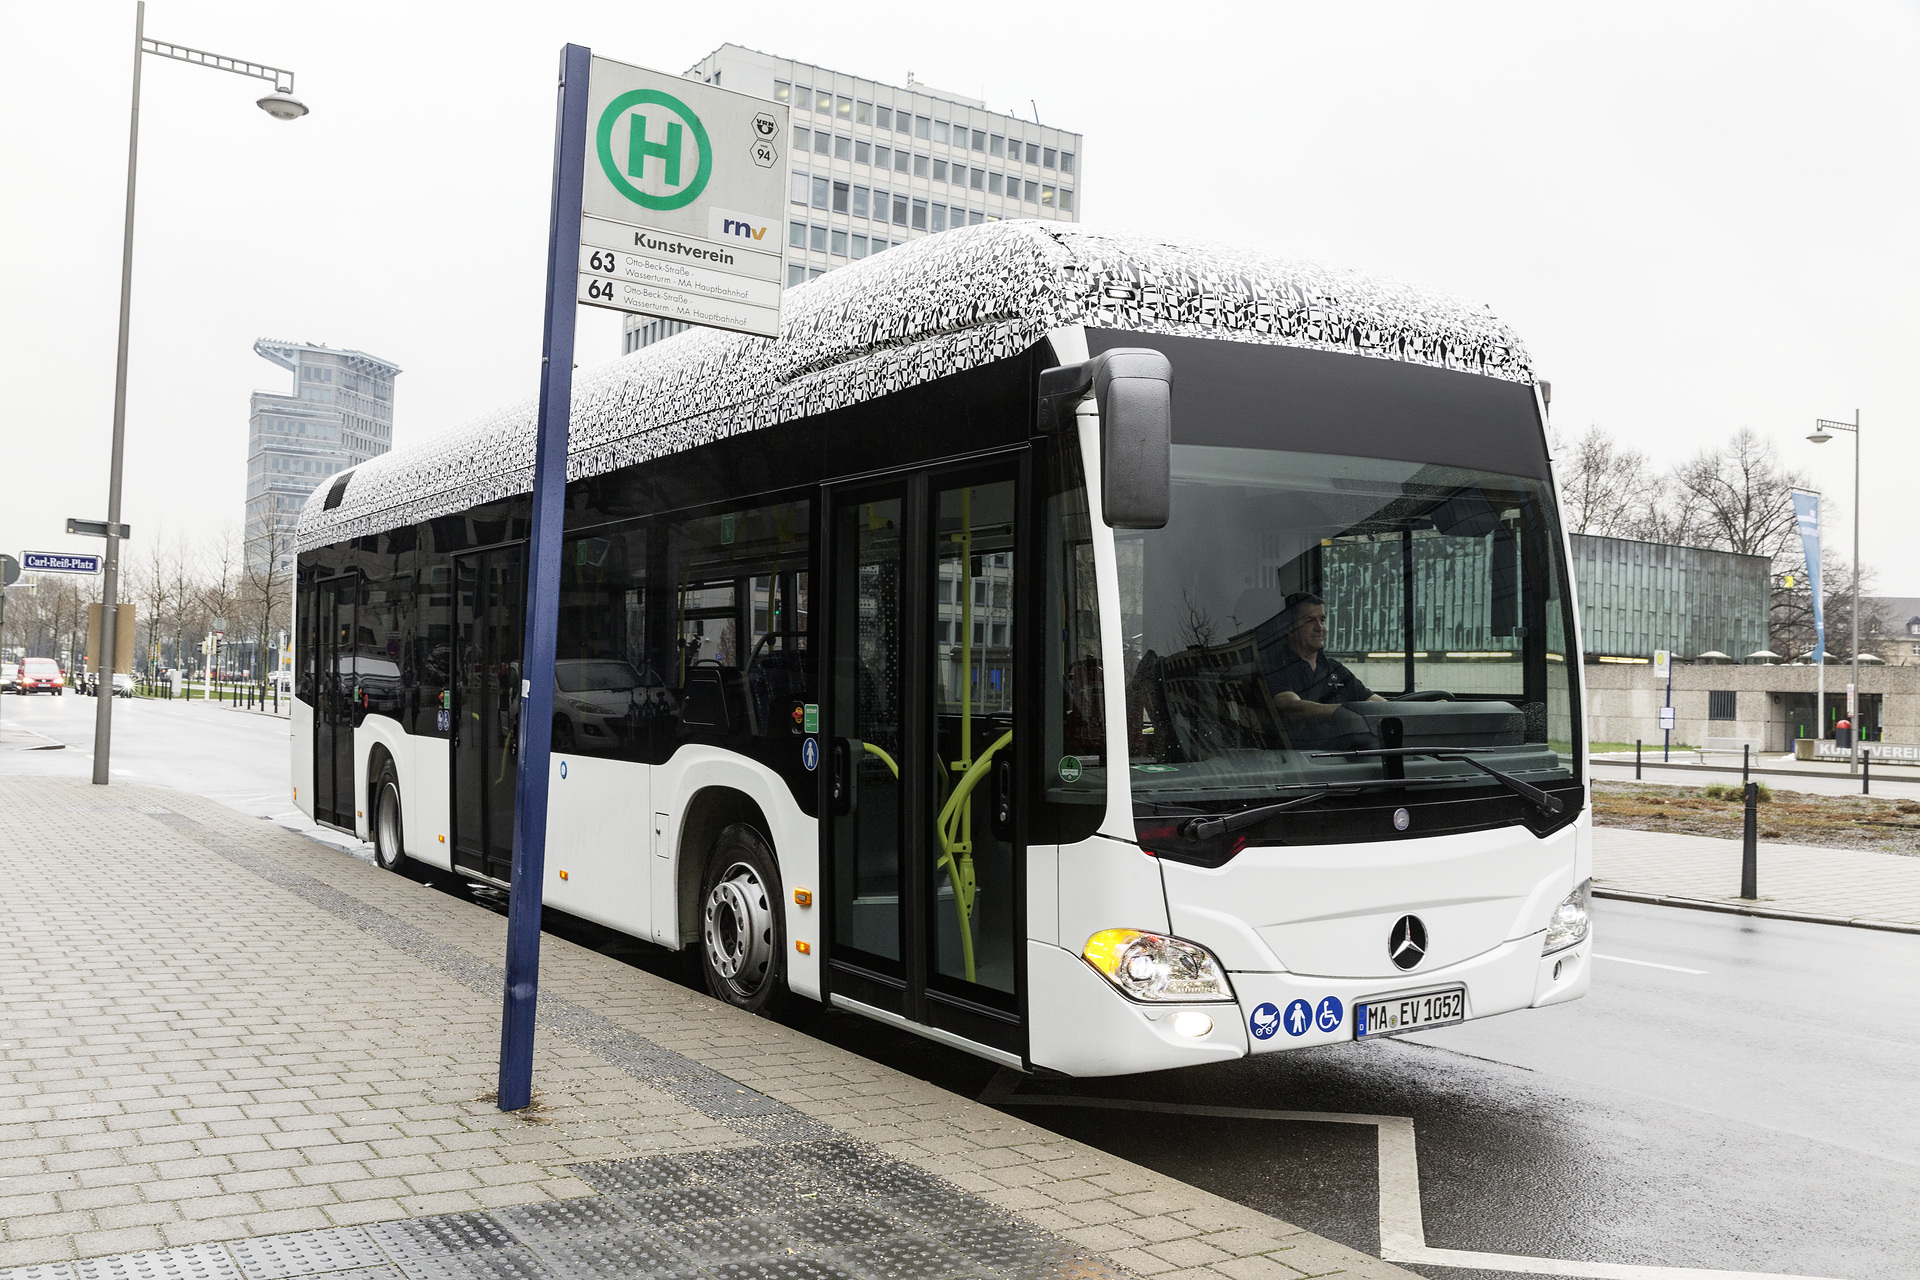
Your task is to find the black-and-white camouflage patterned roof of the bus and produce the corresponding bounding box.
[296,221,1532,551]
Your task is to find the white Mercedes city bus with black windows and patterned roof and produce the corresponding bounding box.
[292,223,1592,1075]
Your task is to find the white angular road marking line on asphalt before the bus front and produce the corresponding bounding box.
[979,1074,1828,1280]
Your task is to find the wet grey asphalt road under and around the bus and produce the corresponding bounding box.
[0,697,1920,1280]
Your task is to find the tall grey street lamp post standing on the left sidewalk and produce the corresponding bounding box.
[94,0,307,787]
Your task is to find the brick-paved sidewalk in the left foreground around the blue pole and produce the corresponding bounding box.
[0,777,1409,1280]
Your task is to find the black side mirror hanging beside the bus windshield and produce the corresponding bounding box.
[1041,347,1173,530]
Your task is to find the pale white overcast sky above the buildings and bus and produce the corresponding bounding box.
[0,0,1920,595]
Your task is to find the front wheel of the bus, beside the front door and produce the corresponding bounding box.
[695,823,787,1013]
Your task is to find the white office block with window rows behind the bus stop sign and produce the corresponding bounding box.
[622,44,1081,351]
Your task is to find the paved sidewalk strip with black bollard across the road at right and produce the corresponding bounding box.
[1594,827,1920,931]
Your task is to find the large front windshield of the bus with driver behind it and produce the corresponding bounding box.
[1117,443,1576,818]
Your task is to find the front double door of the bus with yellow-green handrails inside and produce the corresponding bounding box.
[822,462,1025,1055]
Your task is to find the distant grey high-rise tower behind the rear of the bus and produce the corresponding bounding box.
[246,338,399,572]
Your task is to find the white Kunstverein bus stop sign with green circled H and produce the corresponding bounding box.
[578,58,787,338]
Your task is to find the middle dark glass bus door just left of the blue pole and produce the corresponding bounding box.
[451,543,526,881]
